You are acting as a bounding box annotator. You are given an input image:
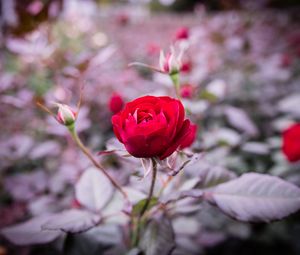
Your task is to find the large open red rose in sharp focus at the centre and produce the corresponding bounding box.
[112,96,196,159]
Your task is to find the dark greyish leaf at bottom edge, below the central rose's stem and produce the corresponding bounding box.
[139,216,175,255]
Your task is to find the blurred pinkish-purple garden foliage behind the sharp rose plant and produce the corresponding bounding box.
[0,0,300,255]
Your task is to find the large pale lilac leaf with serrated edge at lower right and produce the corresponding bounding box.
[204,173,300,222]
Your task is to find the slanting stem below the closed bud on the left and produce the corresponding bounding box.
[68,124,127,199]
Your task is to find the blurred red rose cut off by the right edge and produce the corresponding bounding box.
[282,123,300,162]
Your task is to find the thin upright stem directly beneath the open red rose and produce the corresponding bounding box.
[133,159,157,247]
